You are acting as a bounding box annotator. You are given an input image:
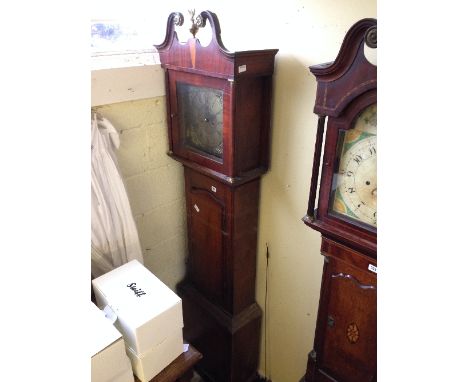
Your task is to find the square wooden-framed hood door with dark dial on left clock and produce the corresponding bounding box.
[169,72,232,175]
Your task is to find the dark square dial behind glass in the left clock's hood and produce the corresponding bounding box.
[176,82,223,159]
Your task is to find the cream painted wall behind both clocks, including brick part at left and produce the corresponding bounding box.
[90,0,376,382]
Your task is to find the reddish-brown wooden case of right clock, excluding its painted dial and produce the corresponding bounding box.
[301,19,377,382]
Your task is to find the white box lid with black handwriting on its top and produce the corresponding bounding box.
[92,260,183,358]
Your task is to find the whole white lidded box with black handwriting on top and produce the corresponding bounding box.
[92,260,183,382]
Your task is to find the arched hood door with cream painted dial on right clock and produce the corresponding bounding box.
[310,90,377,257]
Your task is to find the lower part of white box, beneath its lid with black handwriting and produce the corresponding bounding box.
[126,329,183,382]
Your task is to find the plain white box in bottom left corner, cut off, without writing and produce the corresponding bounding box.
[90,302,133,382]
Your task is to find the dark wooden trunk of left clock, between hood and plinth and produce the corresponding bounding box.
[185,168,260,314]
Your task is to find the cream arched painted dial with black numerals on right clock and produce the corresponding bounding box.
[330,104,377,227]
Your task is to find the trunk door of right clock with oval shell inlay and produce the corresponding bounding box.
[317,257,377,382]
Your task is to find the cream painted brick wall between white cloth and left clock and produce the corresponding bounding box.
[93,97,187,290]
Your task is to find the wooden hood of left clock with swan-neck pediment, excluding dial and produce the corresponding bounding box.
[156,12,278,179]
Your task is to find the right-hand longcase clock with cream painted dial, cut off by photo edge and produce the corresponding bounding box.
[302,19,377,382]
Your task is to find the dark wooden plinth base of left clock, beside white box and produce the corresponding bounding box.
[177,282,262,382]
